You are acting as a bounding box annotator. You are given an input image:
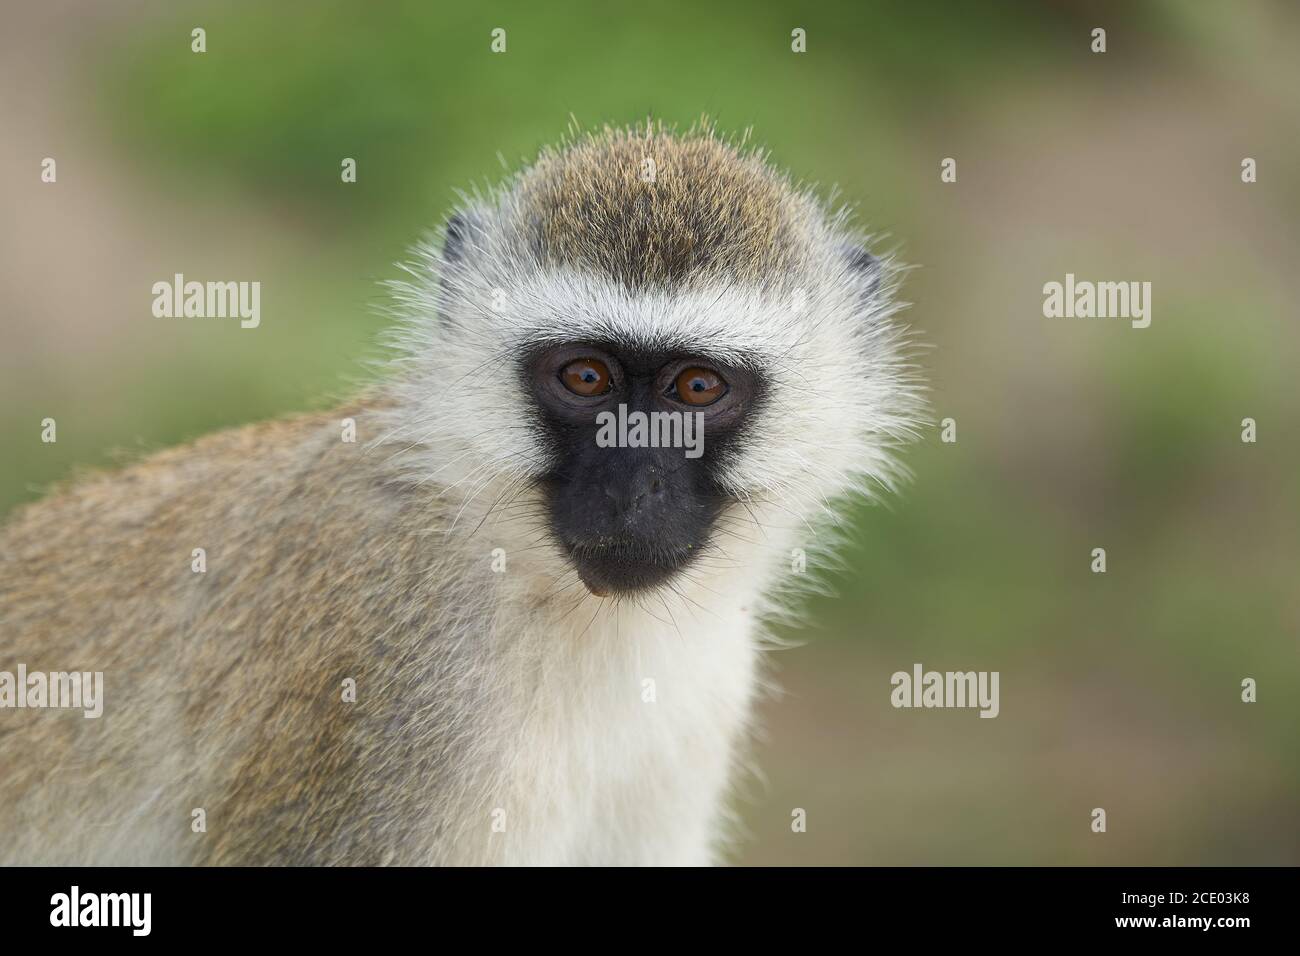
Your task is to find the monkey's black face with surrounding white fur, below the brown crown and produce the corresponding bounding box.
[395,252,915,594]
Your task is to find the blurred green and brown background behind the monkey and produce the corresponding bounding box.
[0,0,1300,864]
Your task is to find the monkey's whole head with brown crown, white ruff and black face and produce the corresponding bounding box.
[384,120,920,594]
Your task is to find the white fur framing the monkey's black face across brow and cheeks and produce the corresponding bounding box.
[379,250,922,514]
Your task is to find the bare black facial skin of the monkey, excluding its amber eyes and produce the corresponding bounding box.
[524,342,762,596]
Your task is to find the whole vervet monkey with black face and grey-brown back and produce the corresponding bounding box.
[0,125,922,865]
